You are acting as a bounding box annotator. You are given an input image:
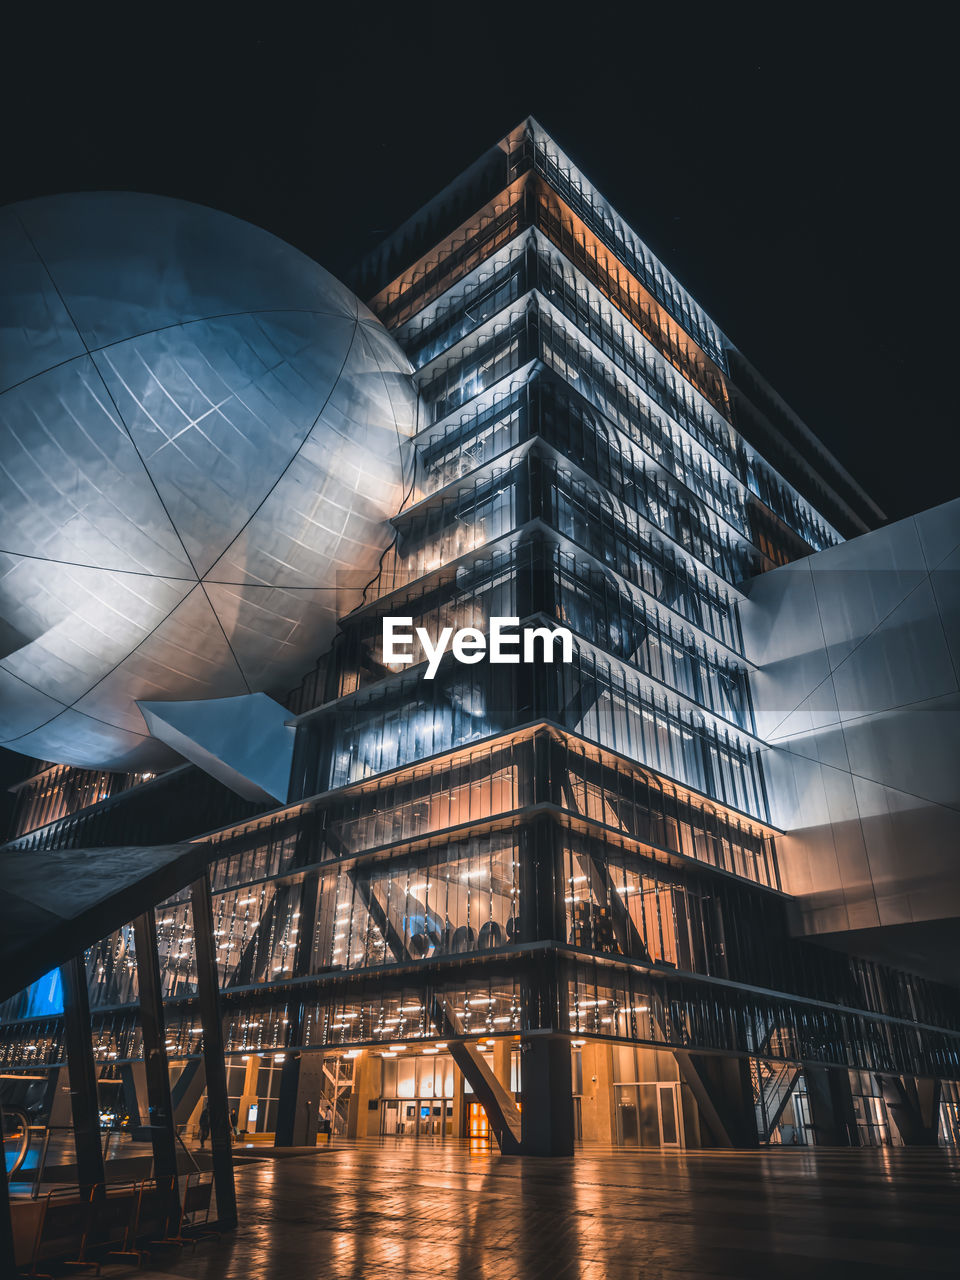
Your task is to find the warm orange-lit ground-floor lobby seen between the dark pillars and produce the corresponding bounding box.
[176,1036,960,1151]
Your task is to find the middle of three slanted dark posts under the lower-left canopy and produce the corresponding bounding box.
[132,910,177,1180]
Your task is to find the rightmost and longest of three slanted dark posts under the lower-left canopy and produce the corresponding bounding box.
[191,874,237,1228]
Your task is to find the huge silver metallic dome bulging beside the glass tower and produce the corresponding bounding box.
[0,192,415,769]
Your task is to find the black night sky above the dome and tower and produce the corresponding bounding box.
[0,3,960,808]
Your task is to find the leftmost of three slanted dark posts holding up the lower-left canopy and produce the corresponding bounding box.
[60,952,106,1196]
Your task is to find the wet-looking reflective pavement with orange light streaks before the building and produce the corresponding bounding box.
[104,1139,960,1280]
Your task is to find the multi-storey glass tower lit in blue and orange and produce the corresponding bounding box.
[3,120,960,1153]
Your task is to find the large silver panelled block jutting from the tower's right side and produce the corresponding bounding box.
[744,502,960,933]
